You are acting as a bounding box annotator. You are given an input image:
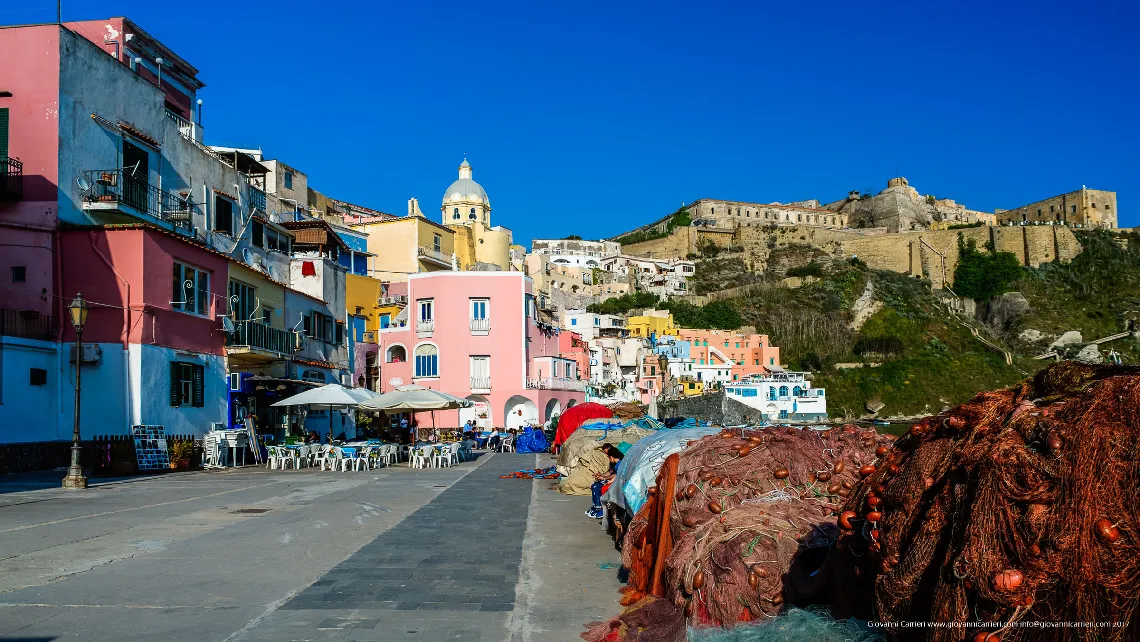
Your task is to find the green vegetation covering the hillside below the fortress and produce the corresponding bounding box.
[601,230,1140,418]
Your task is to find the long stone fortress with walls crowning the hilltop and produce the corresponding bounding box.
[610,177,1118,289]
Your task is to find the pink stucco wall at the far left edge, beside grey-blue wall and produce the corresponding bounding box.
[0,25,59,315]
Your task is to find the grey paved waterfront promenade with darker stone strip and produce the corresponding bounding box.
[0,454,619,641]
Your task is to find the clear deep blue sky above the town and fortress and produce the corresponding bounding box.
[11,0,1140,244]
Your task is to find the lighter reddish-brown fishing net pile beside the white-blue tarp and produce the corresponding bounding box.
[622,425,891,626]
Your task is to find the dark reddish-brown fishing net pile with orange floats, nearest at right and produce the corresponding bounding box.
[837,363,1140,642]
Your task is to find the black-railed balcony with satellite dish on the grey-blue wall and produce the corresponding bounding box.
[80,168,193,231]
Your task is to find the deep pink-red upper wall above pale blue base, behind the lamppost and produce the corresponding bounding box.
[60,228,229,355]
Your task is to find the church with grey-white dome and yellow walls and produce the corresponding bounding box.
[440,159,512,270]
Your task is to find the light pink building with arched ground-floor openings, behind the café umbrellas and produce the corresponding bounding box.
[377,271,585,429]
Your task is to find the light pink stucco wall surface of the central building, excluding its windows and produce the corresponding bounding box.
[378,271,584,426]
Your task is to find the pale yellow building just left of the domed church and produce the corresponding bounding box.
[349,205,458,283]
